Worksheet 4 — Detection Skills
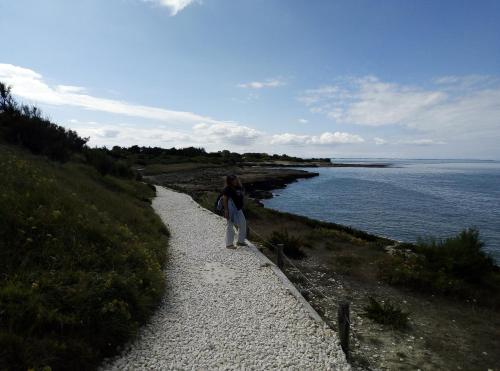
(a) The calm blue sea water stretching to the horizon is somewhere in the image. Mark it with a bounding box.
[264,159,500,262]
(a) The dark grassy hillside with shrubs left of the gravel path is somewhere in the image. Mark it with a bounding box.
[0,84,168,370]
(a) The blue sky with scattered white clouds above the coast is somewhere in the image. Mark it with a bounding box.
[0,0,500,159]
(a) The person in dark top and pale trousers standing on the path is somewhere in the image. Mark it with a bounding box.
[222,175,247,249]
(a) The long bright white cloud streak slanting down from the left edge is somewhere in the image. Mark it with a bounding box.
[0,63,231,125]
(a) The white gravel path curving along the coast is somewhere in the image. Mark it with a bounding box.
[103,187,349,370]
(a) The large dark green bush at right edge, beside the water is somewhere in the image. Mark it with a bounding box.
[379,228,500,306]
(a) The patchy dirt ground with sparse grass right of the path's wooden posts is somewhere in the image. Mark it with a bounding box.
[276,247,500,370]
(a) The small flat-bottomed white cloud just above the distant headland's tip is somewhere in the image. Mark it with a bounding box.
[271,131,365,145]
